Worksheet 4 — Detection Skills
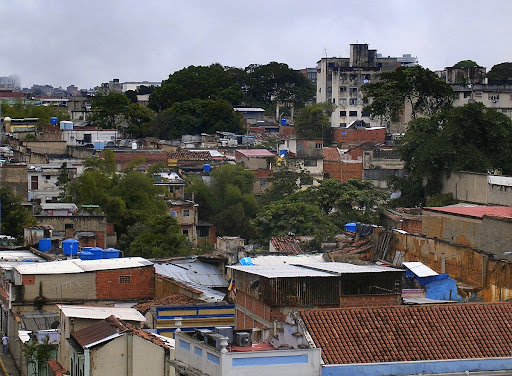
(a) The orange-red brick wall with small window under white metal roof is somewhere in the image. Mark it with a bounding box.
[96,265,155,300]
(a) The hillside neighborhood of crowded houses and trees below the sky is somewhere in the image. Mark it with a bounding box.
[0,43,512,376]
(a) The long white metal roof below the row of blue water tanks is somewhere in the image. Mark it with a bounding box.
[14,257,153,275]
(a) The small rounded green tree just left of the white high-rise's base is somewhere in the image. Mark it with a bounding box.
[294,104,332,143]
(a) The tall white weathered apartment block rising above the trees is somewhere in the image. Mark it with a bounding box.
[316,44,400,128]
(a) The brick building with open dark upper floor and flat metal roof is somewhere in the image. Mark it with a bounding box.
[228,262,404,339]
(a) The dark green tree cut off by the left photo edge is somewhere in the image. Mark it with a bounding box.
[0,186,36,242]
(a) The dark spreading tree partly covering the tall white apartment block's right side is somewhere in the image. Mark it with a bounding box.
[362,65,453,122]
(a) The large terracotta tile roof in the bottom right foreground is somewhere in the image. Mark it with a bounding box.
[301,303,512,364]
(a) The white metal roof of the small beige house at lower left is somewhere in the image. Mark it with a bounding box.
[59,305,146,322]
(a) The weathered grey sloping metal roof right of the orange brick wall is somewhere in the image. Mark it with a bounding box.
[155,260,228,287]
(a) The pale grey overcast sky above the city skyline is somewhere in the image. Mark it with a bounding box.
[4,0,512,88]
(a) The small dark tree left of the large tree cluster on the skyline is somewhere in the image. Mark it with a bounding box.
[91,92,130,129]
